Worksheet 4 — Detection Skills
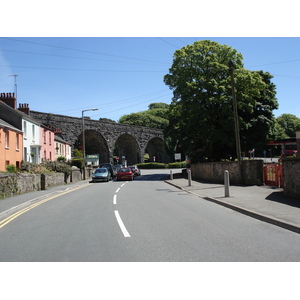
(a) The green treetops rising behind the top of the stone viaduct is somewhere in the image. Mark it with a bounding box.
[119,103,169,129]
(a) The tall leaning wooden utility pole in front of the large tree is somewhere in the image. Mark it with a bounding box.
[229,61,242,179]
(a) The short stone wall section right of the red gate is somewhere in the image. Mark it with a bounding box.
[282,158,300,199]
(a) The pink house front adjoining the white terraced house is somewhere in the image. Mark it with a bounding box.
[40,125,55,161]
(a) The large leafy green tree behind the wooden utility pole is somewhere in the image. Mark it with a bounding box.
[164,40,276,161]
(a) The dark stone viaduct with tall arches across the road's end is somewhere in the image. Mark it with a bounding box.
[30,110,171,165]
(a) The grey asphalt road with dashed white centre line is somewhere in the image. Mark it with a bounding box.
[0,170,300,262]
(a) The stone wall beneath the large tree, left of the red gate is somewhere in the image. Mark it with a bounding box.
[191,160,263,185]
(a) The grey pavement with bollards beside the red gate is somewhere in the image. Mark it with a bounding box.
[165,178,300,233]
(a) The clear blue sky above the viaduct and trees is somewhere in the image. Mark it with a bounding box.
[0,37,300,121]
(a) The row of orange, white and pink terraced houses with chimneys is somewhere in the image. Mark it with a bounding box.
[0,93,71,171]
